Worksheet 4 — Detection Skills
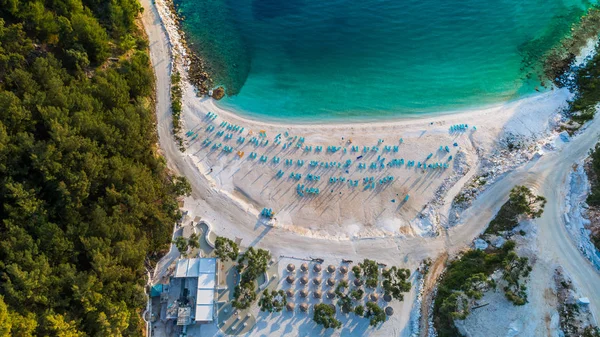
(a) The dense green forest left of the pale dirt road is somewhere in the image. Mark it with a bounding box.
[0,0,189,337]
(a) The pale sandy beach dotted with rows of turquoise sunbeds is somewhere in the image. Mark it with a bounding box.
[179,81,568,239]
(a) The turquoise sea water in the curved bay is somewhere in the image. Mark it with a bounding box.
[175,0,591,120]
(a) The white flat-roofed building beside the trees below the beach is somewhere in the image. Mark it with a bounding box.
[174,258,217,323]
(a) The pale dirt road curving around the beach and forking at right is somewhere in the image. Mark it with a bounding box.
[142,0,600,332]
